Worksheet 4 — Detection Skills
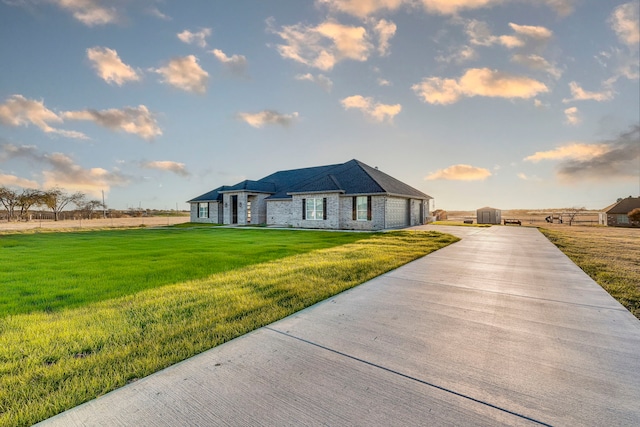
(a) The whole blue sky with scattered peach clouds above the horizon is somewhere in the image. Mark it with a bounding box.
[0,0,640,210]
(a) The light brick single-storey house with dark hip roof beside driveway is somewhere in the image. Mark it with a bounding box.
[188,160,432,230]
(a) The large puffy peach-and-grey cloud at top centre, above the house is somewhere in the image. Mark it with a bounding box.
[267,19,373,71]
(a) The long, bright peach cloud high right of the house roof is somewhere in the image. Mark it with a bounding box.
[411,68,549,105]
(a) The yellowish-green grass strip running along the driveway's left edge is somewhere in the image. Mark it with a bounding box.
[0,230,458,426]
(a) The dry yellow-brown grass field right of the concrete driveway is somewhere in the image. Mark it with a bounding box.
[540,225,640,319]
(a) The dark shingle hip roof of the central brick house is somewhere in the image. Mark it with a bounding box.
[189,159,431,202]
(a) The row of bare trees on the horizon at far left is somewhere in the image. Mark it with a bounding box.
[0,186,106,221]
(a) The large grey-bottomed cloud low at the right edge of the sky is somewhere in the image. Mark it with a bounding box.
[525,125,640,183]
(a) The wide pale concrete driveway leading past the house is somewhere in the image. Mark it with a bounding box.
[37,226,640,426]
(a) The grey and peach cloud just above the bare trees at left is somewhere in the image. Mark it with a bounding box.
[0,144,130,196]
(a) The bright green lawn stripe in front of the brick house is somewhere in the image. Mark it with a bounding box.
[0,228,371,317]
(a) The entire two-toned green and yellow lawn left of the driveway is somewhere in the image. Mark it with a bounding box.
[0,228,457,426]
